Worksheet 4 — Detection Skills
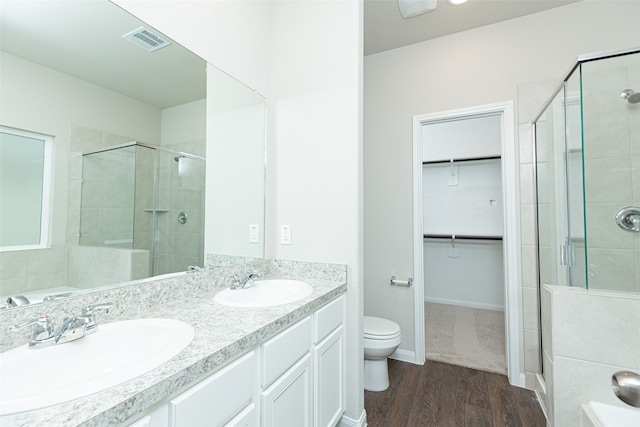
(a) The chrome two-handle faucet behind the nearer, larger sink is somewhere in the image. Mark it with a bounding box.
[11,303,113,349]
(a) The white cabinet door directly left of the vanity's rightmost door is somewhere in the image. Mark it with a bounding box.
[262,353,311,427]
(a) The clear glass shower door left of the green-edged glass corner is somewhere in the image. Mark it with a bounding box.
[535,73,587,288]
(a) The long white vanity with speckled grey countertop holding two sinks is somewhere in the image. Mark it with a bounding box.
[0,263,346,427]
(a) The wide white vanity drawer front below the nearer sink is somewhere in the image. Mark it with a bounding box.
[169,351,257,427]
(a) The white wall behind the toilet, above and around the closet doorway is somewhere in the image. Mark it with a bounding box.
[364,0,640,387]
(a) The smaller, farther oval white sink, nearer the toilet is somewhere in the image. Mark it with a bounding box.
[213,279,313,307]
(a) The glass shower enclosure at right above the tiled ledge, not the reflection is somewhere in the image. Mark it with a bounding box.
[535,50,640,292]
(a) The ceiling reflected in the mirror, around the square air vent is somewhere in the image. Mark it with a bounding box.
[0,0,206,109]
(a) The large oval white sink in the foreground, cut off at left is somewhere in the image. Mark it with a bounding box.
[0,319,194,415]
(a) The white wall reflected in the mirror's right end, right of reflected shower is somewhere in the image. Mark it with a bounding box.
[205,67,266,258]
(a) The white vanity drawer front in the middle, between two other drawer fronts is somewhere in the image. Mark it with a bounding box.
[260,316,311,387]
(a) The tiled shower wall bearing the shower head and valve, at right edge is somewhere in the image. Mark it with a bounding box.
[582,54,640,292]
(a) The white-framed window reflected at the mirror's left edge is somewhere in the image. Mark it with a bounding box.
[0,126,52,251]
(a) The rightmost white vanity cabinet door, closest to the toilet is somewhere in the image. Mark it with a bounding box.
[313,326,345,427]
